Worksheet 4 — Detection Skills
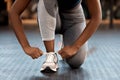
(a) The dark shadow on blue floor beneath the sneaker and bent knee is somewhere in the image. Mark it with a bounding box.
[24,61,89,80]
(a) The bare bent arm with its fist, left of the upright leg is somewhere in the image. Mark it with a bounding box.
[9,0,42,59]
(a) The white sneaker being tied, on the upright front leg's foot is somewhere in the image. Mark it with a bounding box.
[40,52,58,72]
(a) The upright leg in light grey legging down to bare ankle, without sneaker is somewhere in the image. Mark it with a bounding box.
[38,0,57,52]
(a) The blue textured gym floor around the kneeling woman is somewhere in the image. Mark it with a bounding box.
[0,27,120,80]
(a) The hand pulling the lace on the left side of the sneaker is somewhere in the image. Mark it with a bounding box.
[24,47,43,59]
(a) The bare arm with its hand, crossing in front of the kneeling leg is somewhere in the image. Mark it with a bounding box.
[59,0,102,58]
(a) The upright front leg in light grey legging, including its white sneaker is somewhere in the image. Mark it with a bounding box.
[38,0,61,71]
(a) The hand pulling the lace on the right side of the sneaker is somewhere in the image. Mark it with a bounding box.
[58,46,78,58]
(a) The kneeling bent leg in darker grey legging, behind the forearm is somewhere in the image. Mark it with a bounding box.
[60,5,88,68]
